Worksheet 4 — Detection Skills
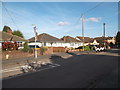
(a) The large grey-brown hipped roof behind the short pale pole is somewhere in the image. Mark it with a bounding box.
[28,33,63,42]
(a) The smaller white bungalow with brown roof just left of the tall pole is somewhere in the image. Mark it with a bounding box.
[61,36,82,48]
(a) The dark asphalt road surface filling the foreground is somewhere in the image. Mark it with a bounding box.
[2,48,119,88]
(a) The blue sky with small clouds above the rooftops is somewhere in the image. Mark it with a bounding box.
[0,2,118,39]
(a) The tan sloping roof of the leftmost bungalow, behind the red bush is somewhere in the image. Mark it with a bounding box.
[0,31,27,41]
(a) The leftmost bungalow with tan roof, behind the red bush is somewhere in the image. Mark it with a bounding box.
[0,31,27,47]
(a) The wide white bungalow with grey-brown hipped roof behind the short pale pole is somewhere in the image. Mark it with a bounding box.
[28,33,64,47]
